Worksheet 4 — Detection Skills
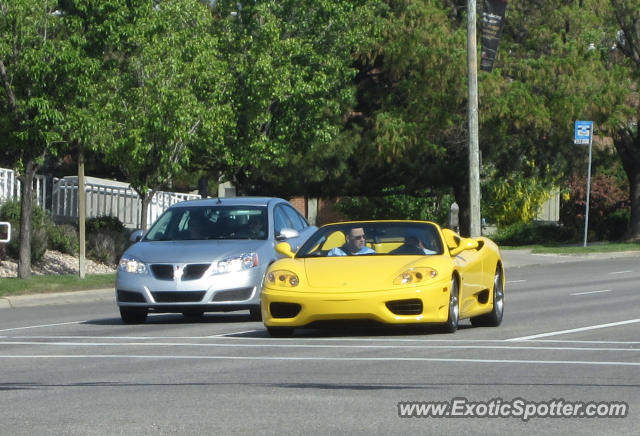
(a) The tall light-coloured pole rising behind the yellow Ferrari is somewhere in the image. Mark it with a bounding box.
[467,0,482,236]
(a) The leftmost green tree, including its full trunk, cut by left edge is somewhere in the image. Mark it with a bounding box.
[0,0,82,278]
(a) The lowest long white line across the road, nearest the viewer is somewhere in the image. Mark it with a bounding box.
[0,354,640,366]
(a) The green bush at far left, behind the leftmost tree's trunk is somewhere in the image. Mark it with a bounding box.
[0,201,52,262]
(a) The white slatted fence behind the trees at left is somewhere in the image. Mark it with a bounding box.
[0,168,200,228]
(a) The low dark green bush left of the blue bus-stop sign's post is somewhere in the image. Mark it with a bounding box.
[491,222,578,246]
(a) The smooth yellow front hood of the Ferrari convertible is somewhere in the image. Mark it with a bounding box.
[304,256,444,292]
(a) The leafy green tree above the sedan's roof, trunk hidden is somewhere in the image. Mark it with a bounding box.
[194,0,365,195]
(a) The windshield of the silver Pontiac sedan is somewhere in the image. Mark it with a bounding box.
[143,206,268,241]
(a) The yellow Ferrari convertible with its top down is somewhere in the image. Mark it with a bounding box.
[261,221,505,336]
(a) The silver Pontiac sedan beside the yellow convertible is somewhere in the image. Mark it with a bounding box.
[116,197,316,323]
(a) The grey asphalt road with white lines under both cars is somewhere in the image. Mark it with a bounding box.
[0,254,640,435]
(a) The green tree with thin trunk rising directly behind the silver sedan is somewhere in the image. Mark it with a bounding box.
[95,0,232,228]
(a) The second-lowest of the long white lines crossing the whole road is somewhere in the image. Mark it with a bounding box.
[0,341,640,352]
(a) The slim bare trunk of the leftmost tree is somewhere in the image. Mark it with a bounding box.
[18,160,36,279]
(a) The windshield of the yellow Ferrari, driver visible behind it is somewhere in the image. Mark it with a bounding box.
[296,221,443,258]
